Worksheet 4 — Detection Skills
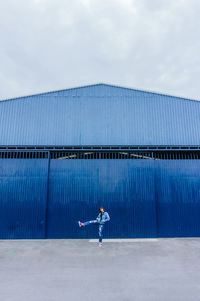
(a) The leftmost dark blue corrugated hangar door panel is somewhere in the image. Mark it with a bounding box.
[0,159,48,239]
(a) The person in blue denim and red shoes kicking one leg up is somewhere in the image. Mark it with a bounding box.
[78,206,110,247]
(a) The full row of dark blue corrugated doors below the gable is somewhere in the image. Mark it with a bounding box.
[0,159,200,239]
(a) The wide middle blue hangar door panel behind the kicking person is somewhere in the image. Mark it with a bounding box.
[47,158,157,238]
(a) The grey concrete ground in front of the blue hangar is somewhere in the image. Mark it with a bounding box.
[0,238,200,301]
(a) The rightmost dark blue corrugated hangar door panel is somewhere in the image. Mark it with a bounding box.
[155,160,200,237]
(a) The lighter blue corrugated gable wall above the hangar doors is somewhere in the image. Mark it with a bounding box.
[0,84,200,145]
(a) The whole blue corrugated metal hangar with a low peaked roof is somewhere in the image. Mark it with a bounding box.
[0,84,200,238]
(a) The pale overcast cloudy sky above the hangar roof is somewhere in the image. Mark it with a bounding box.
[0,0,200,99]
